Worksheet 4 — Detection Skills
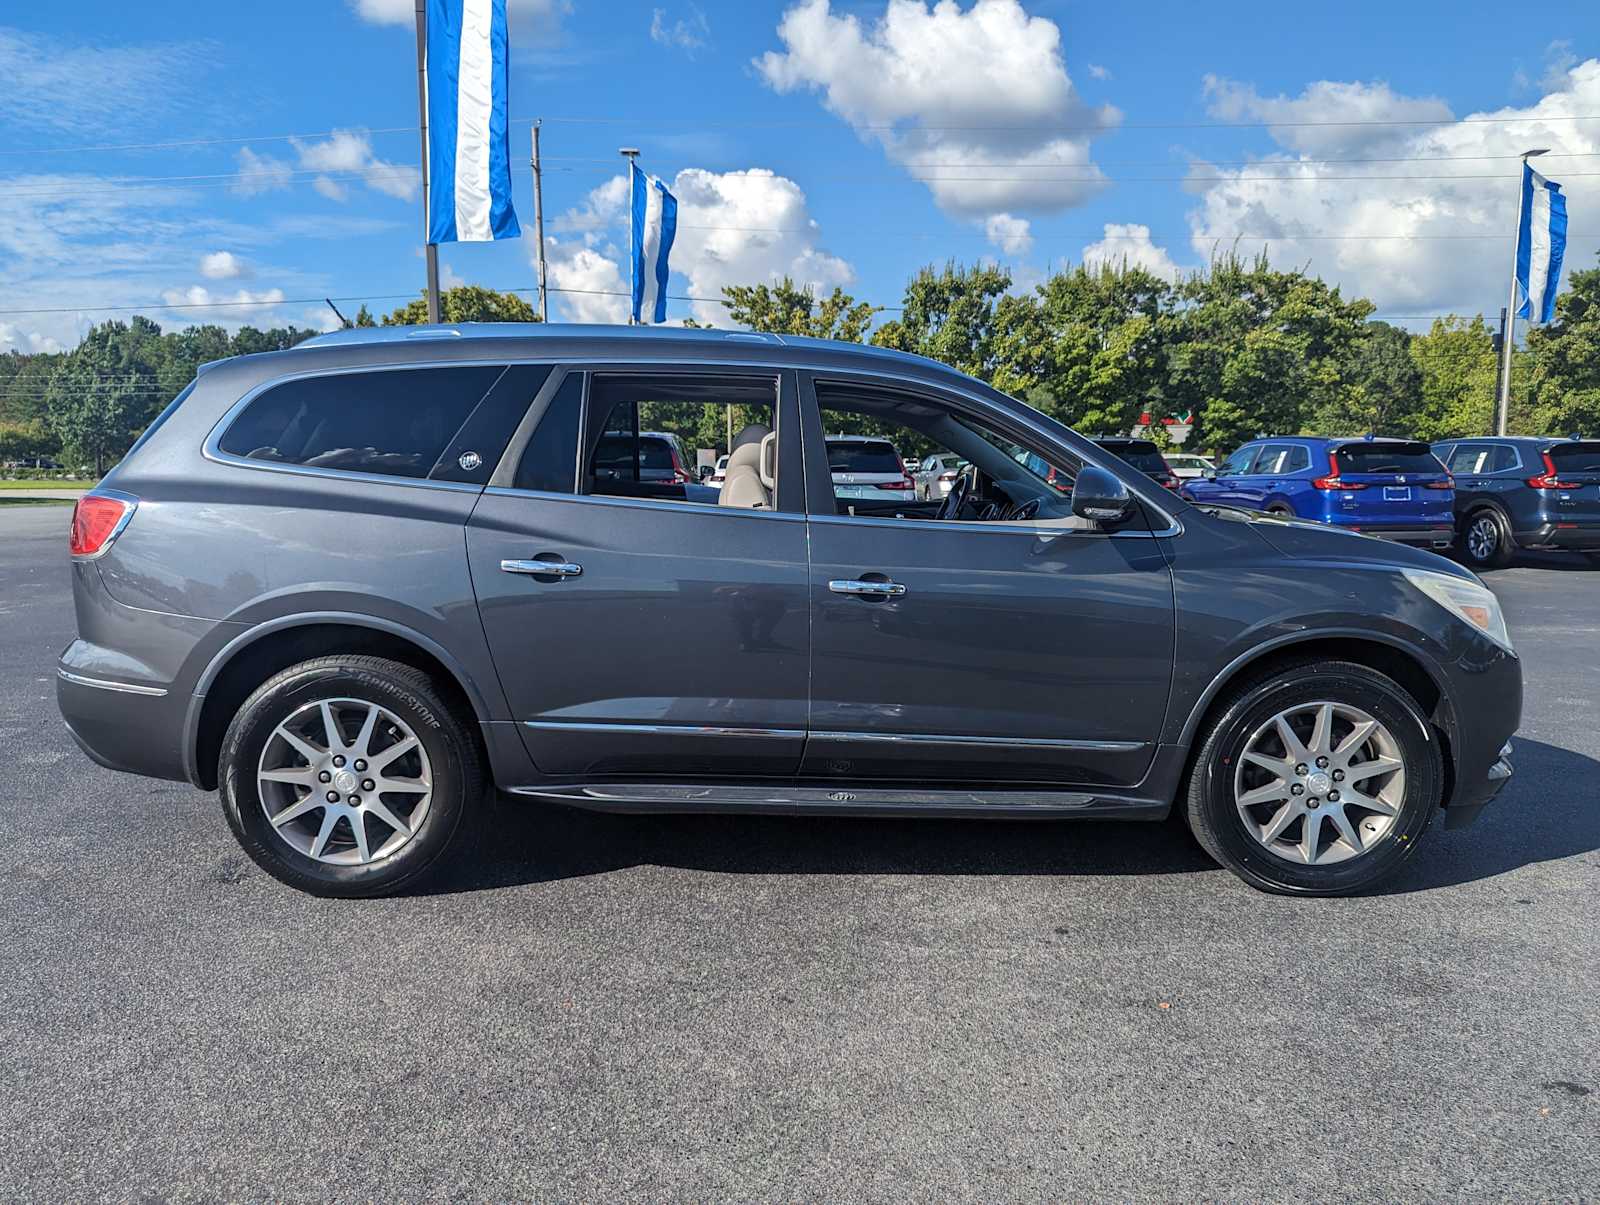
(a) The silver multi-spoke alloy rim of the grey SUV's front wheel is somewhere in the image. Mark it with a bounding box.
[1234,703,1405,866]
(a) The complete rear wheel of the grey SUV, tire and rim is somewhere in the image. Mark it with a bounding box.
[218,656,483,896]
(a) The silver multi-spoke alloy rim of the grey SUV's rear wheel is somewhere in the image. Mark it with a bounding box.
[256,699,434,866]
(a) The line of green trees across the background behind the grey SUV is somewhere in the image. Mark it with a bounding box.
[0,253,1600,474]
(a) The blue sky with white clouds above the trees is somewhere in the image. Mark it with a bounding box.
[0,0,1600,349]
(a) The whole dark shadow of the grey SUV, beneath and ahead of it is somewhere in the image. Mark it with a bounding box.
[422,739,1600,895]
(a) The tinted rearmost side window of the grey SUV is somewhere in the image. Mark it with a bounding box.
[218,366,504,477]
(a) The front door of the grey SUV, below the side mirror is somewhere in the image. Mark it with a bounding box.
[802,381,1173,787]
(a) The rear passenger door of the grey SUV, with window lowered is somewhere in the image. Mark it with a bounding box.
[467,368,810,783]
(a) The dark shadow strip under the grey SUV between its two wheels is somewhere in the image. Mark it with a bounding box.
[422,800,1219,893]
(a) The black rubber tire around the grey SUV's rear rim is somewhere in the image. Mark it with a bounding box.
[218,666,467,896]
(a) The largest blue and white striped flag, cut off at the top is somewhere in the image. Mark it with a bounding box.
[427,0,522,243]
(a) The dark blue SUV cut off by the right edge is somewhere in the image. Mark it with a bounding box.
[1434,435,1600,570]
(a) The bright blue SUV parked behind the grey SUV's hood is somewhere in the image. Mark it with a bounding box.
[1179,435,1456,549]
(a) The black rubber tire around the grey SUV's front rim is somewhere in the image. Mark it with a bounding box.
[1195,666,1443,895]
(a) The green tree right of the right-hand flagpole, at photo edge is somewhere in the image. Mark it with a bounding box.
[1512,254,1600,435]
